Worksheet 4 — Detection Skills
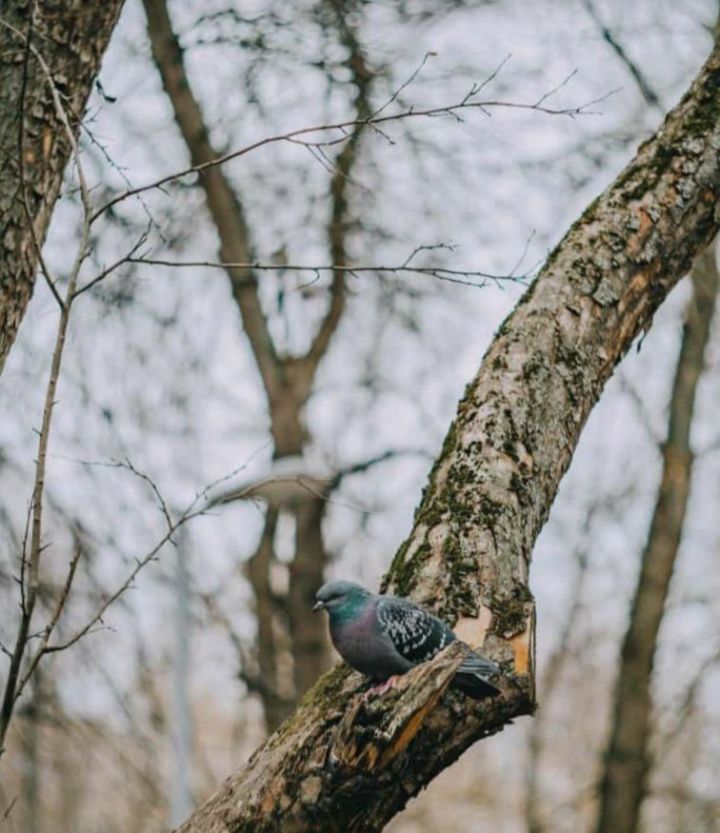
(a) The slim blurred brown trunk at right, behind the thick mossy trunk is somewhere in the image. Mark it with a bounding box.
[596,247,718,833]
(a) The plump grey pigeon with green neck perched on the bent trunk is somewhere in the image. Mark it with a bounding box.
[313,581,501,700]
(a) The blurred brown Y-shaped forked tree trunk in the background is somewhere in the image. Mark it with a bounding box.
[144,0,373,731]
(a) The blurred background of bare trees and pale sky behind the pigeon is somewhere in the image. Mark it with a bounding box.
[0,0,720,833]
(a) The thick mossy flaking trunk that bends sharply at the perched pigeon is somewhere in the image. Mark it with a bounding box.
[173,42,720,833]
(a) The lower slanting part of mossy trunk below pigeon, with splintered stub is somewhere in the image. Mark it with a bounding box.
[178,641,532,833]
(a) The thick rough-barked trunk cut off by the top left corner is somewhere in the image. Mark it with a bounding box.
[0,0,123,372]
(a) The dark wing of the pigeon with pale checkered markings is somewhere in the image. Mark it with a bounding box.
[377,596,455,665]
